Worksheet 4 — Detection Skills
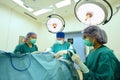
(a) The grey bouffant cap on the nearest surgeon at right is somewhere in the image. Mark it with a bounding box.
[82,26,107,44]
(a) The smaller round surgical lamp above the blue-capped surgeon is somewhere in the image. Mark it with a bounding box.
[46,14,65,33]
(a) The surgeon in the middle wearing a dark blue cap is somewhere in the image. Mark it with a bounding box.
[49,32,75,60]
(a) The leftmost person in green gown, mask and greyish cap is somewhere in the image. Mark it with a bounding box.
[14,32,38,54]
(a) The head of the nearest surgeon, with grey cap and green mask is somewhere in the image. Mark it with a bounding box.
[82,26,107,46]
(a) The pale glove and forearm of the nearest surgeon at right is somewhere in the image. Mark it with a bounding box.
[72,54,89,73]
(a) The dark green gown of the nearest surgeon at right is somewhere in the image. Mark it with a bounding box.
[83,45,119,80]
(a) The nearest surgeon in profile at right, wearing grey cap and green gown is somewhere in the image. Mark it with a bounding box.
[72,26,120,80]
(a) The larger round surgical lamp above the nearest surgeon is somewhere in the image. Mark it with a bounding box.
[74,0,113,25]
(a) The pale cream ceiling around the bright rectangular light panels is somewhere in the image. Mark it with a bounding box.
[0,0,120,23]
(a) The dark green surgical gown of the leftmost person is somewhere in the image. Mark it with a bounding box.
[14,43,38,54]
